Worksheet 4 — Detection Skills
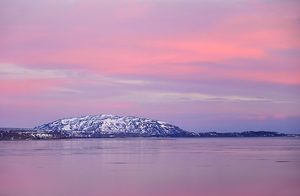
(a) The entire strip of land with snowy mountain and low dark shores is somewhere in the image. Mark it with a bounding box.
[0,114,300,140]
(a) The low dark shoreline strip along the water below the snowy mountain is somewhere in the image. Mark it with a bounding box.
[0,128,300,140]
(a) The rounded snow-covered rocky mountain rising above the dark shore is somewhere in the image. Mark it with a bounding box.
[34,115,191,137]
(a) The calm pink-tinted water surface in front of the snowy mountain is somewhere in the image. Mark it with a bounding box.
[0,138,300,196]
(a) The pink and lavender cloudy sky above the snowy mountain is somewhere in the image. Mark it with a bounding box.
[0,0,300,132]
